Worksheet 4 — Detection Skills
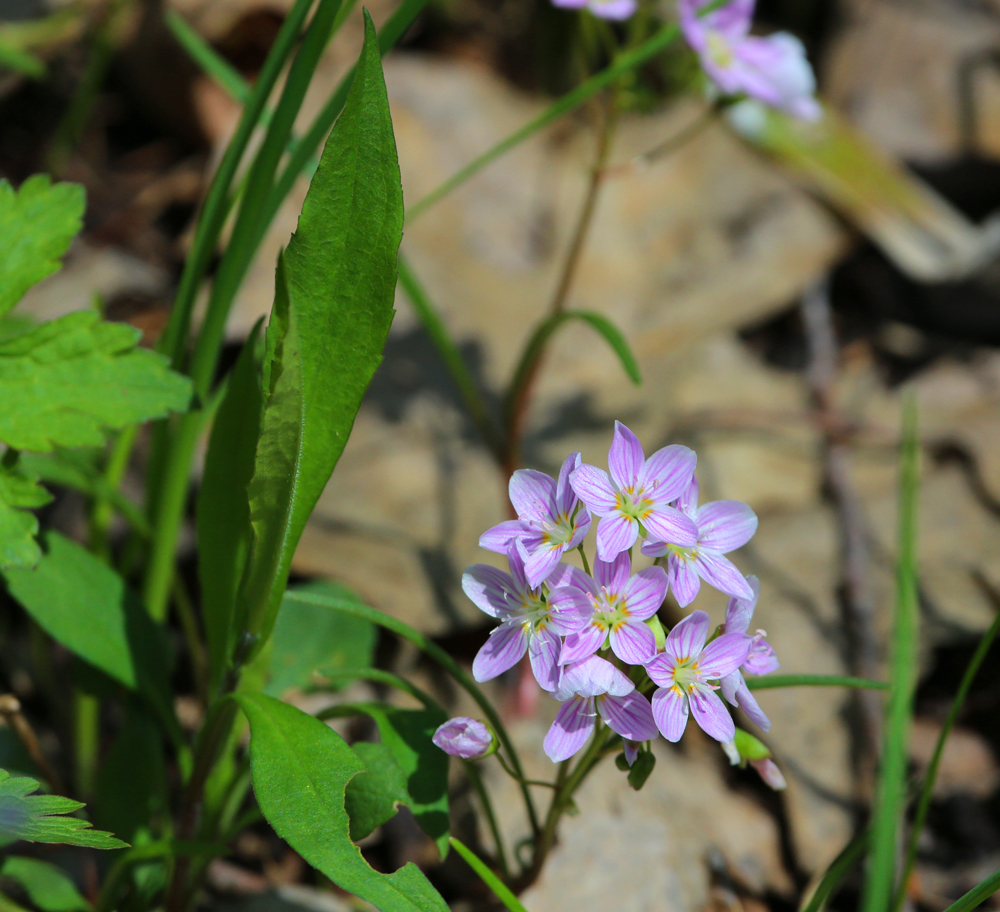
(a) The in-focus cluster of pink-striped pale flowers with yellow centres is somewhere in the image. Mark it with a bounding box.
[456,422,778,763]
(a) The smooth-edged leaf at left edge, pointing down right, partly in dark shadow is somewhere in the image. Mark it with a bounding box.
[4,532,176,726]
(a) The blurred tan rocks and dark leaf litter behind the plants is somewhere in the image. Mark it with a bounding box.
[0,0,1000,912]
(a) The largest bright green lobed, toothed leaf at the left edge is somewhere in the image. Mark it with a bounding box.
[0,311,191,452]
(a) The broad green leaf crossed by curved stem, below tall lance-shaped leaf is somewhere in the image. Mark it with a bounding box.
[264,581,376,697]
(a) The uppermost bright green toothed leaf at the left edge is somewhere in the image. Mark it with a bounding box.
[0,174,85,314]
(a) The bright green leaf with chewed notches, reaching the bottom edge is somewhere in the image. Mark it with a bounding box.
[235,693,448,912]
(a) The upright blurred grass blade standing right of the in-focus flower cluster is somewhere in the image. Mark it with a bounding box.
[861,398,920,912]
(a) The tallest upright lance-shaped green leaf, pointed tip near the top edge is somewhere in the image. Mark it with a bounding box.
[239,15,403,649]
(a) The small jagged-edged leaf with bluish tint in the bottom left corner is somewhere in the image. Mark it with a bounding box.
[0,770,128,849]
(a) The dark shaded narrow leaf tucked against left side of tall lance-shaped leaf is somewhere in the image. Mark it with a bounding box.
[196,323,262,687]
